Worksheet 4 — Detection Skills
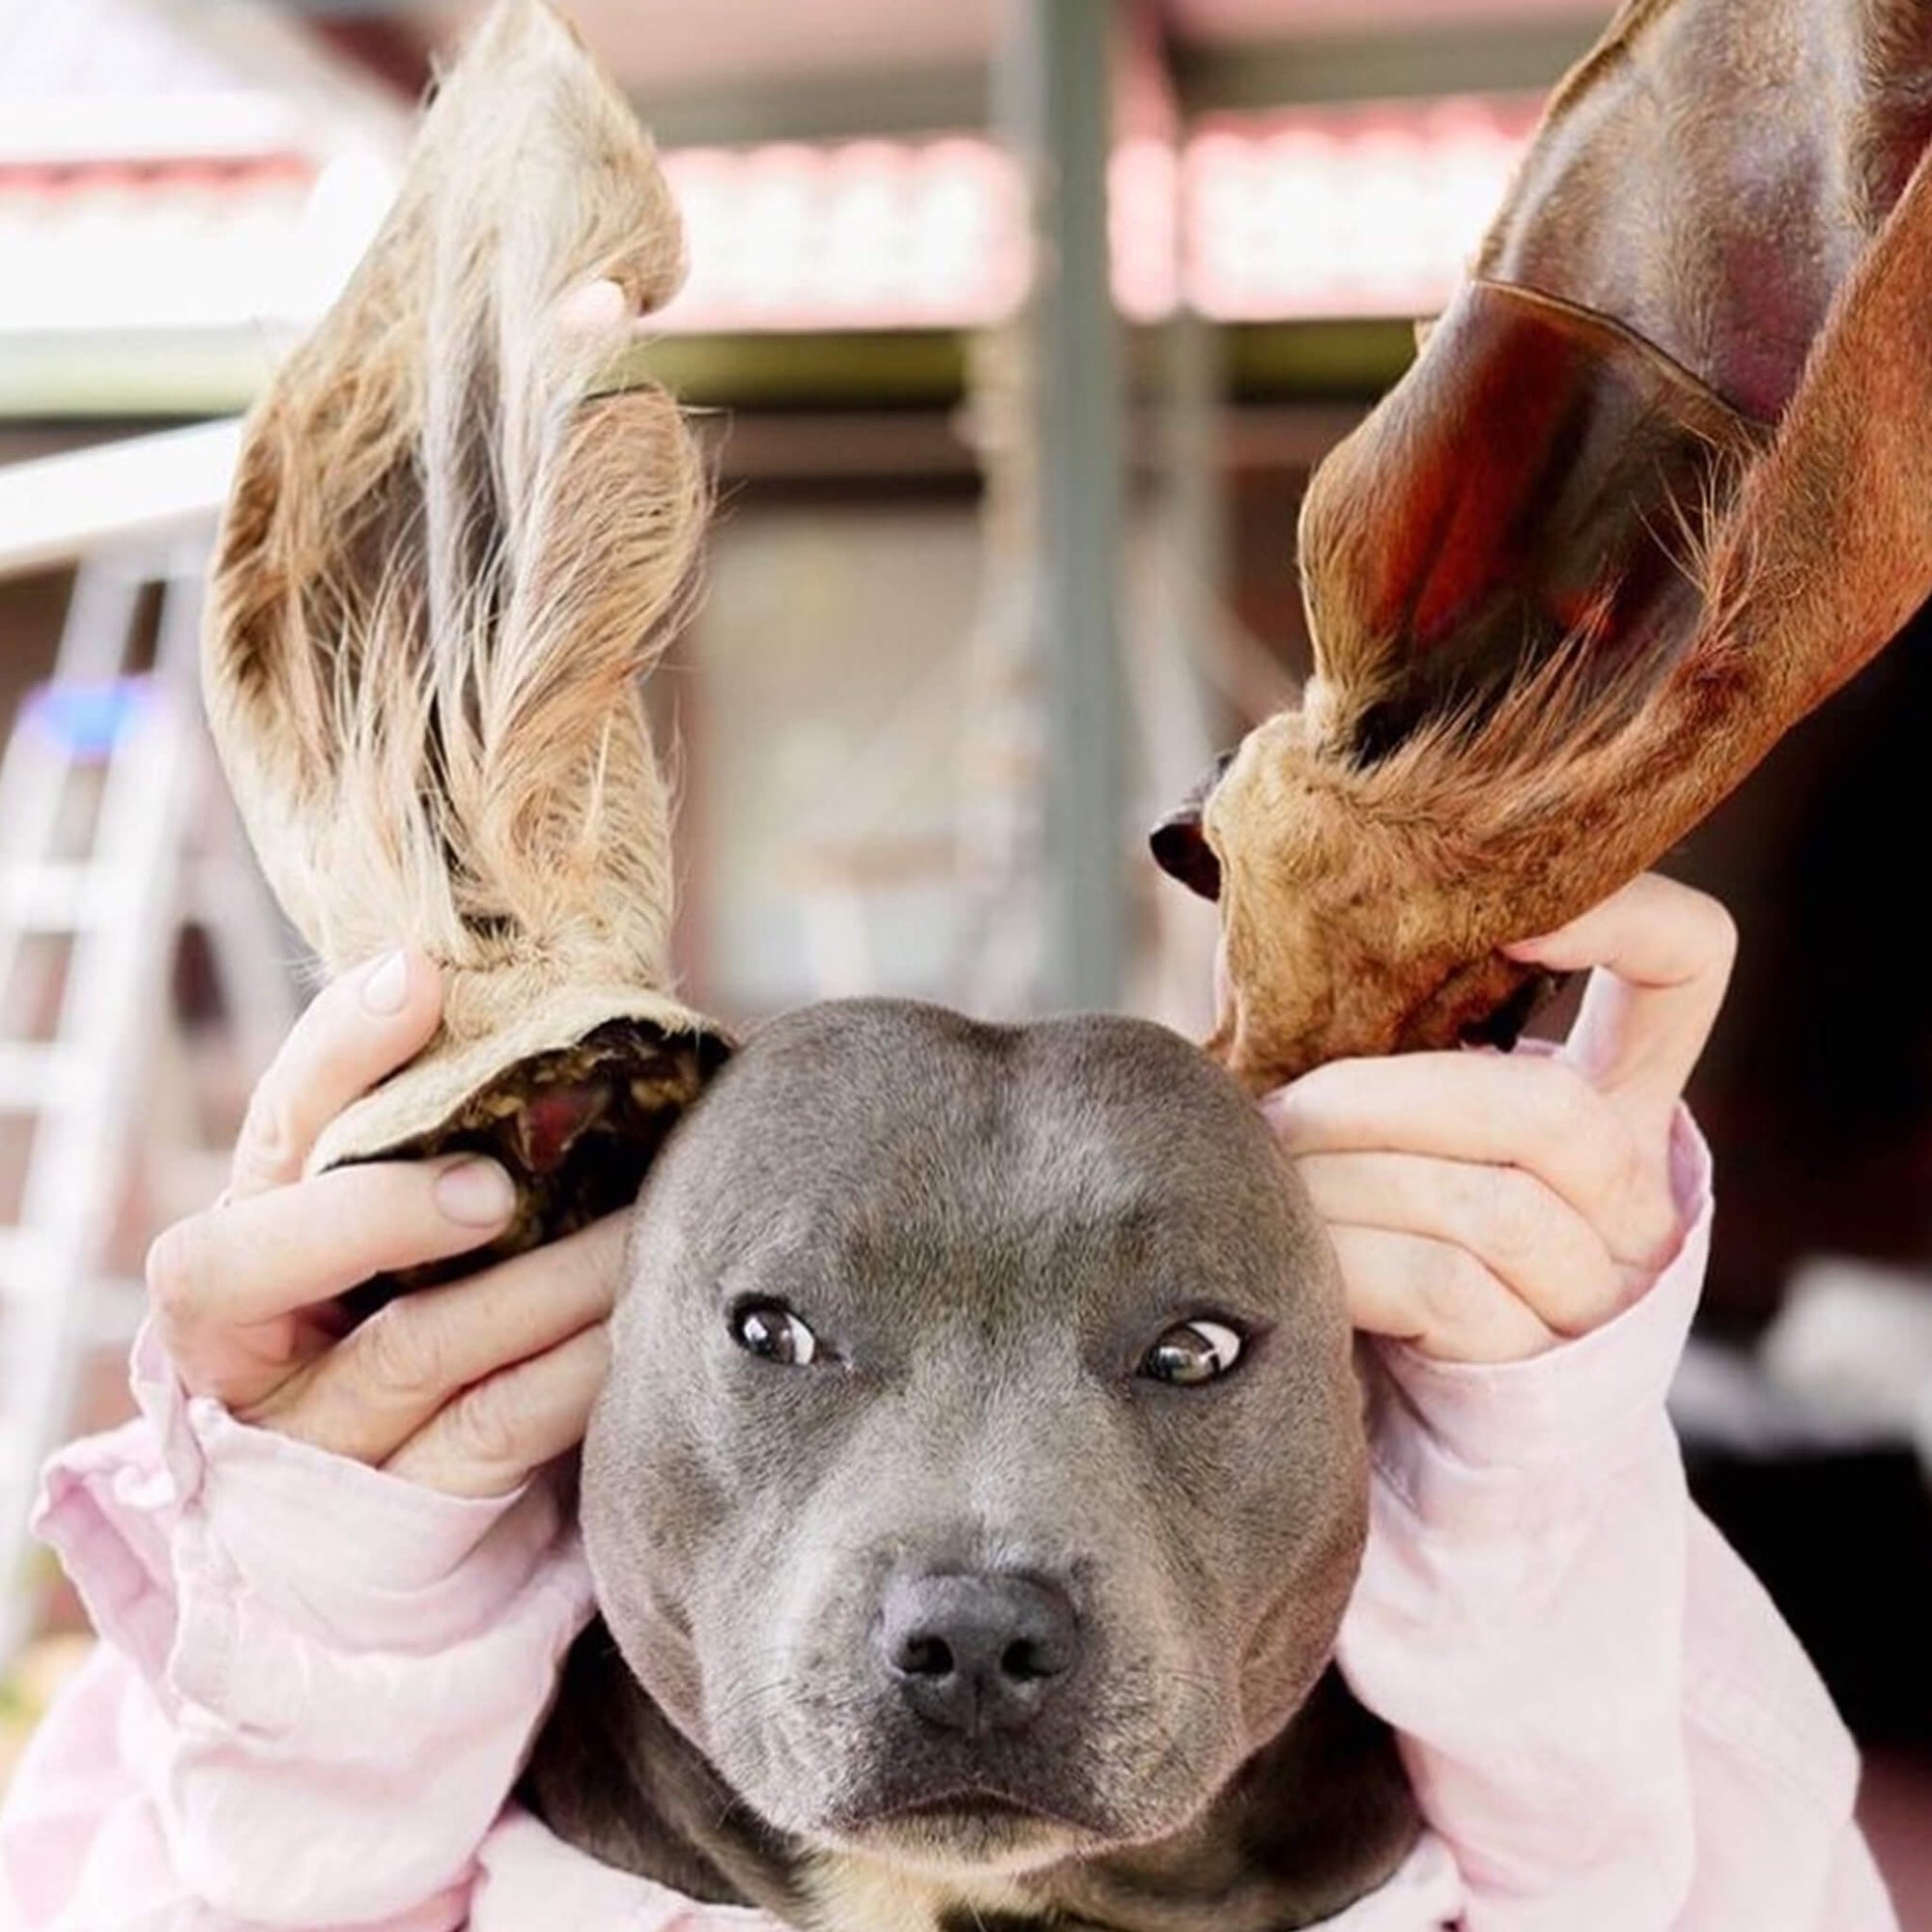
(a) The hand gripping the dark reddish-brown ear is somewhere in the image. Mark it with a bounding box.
[1262,873,1737,1362]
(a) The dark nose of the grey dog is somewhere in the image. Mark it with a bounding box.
[877,1575,1080,1737]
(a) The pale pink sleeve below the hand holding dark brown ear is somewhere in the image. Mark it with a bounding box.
[1341,1117,1895,1932]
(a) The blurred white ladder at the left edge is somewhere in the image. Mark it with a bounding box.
[0,539,292,1665]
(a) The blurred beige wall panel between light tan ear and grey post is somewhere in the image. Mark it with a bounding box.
[688,497,981,1014]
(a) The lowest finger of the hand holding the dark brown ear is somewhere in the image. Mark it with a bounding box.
[1329,1227,1555,1362]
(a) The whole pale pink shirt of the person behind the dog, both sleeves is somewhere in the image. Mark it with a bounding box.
[0,1124,1897,1932]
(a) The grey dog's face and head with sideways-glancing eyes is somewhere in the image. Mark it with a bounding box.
[583,1001,1366,1872]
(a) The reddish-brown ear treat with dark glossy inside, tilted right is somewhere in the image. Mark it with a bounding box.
[1163,0,1932,1088]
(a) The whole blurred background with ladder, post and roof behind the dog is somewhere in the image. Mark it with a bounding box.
[0,0,1932,1926]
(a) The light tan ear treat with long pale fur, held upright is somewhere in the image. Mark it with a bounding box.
[203,0,726,1291]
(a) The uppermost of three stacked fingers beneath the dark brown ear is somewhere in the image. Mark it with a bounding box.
[1262,1053,1673,1258]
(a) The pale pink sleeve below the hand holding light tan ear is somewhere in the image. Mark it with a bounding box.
[0,1341,589,1932]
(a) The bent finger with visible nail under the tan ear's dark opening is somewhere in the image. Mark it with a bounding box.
[147,1155,516,1408]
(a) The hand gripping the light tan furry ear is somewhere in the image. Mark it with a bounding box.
[147,952,624,1495]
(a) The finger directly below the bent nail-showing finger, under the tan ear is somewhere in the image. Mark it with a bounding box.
[249,1215,628,1468]
